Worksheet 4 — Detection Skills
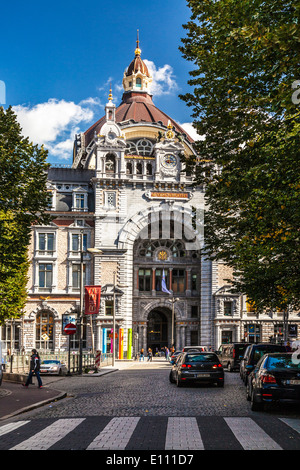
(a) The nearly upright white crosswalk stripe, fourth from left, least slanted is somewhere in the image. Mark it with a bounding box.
[165,417,204,450]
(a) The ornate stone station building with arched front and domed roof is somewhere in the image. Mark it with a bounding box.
[1,41,300,358]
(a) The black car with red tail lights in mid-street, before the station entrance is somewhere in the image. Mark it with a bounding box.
[170,352,224,387]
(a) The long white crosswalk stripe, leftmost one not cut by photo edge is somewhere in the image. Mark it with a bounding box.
[10,418,85,450]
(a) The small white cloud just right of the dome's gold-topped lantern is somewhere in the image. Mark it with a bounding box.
[144,59,178,96]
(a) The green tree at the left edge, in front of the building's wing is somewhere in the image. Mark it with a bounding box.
[0,107,50,323]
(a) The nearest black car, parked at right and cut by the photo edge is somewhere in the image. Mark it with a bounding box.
[247,352,300,411]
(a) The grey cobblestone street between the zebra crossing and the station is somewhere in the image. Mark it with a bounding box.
[22,358,300,418]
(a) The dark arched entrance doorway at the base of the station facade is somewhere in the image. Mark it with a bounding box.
[147,309,169,354]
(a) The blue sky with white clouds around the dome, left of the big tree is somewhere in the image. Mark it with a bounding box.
[0,0,198,165]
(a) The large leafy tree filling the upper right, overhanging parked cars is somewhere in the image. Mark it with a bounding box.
[180,0,300,309]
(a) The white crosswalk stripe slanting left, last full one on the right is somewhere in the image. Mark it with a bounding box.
[224,418,282,450]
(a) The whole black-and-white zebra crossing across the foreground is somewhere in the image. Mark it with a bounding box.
[0,415,300,452]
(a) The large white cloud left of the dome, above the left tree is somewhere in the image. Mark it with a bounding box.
[13,98,101,159]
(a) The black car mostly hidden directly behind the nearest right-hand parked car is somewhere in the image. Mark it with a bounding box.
[240,343,286,385]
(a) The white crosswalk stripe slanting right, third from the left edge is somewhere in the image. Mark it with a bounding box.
[87,417,140,450]
